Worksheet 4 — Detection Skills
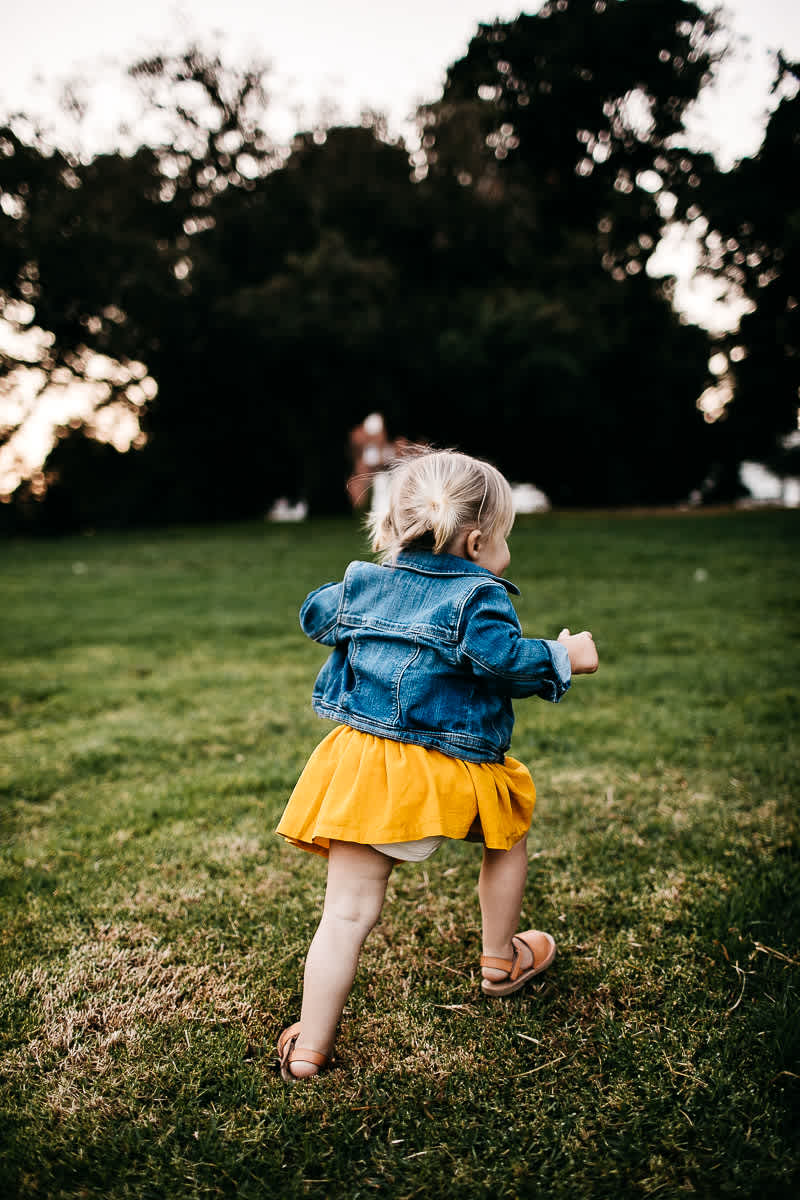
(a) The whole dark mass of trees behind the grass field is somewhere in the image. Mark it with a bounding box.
[0,0,798,528]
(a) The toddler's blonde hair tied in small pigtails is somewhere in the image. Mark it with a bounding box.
[367,448,513,563]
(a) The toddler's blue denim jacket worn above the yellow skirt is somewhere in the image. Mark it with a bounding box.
[300,552,571,762]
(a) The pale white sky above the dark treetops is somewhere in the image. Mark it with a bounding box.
[0,0,800,166]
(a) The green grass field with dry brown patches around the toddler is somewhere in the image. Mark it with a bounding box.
[0,512,800,1200]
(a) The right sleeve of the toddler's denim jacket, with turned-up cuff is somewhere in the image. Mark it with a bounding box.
[461,584,572,704]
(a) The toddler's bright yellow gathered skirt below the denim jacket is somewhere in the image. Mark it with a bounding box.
[277,725,536,857]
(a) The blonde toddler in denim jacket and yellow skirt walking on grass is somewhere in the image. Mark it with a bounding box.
[277,450,597,1080]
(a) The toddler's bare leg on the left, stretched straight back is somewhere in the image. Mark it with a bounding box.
[290,841,395,1079]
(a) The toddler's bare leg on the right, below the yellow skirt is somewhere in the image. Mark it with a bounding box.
[477,838,548,979]
